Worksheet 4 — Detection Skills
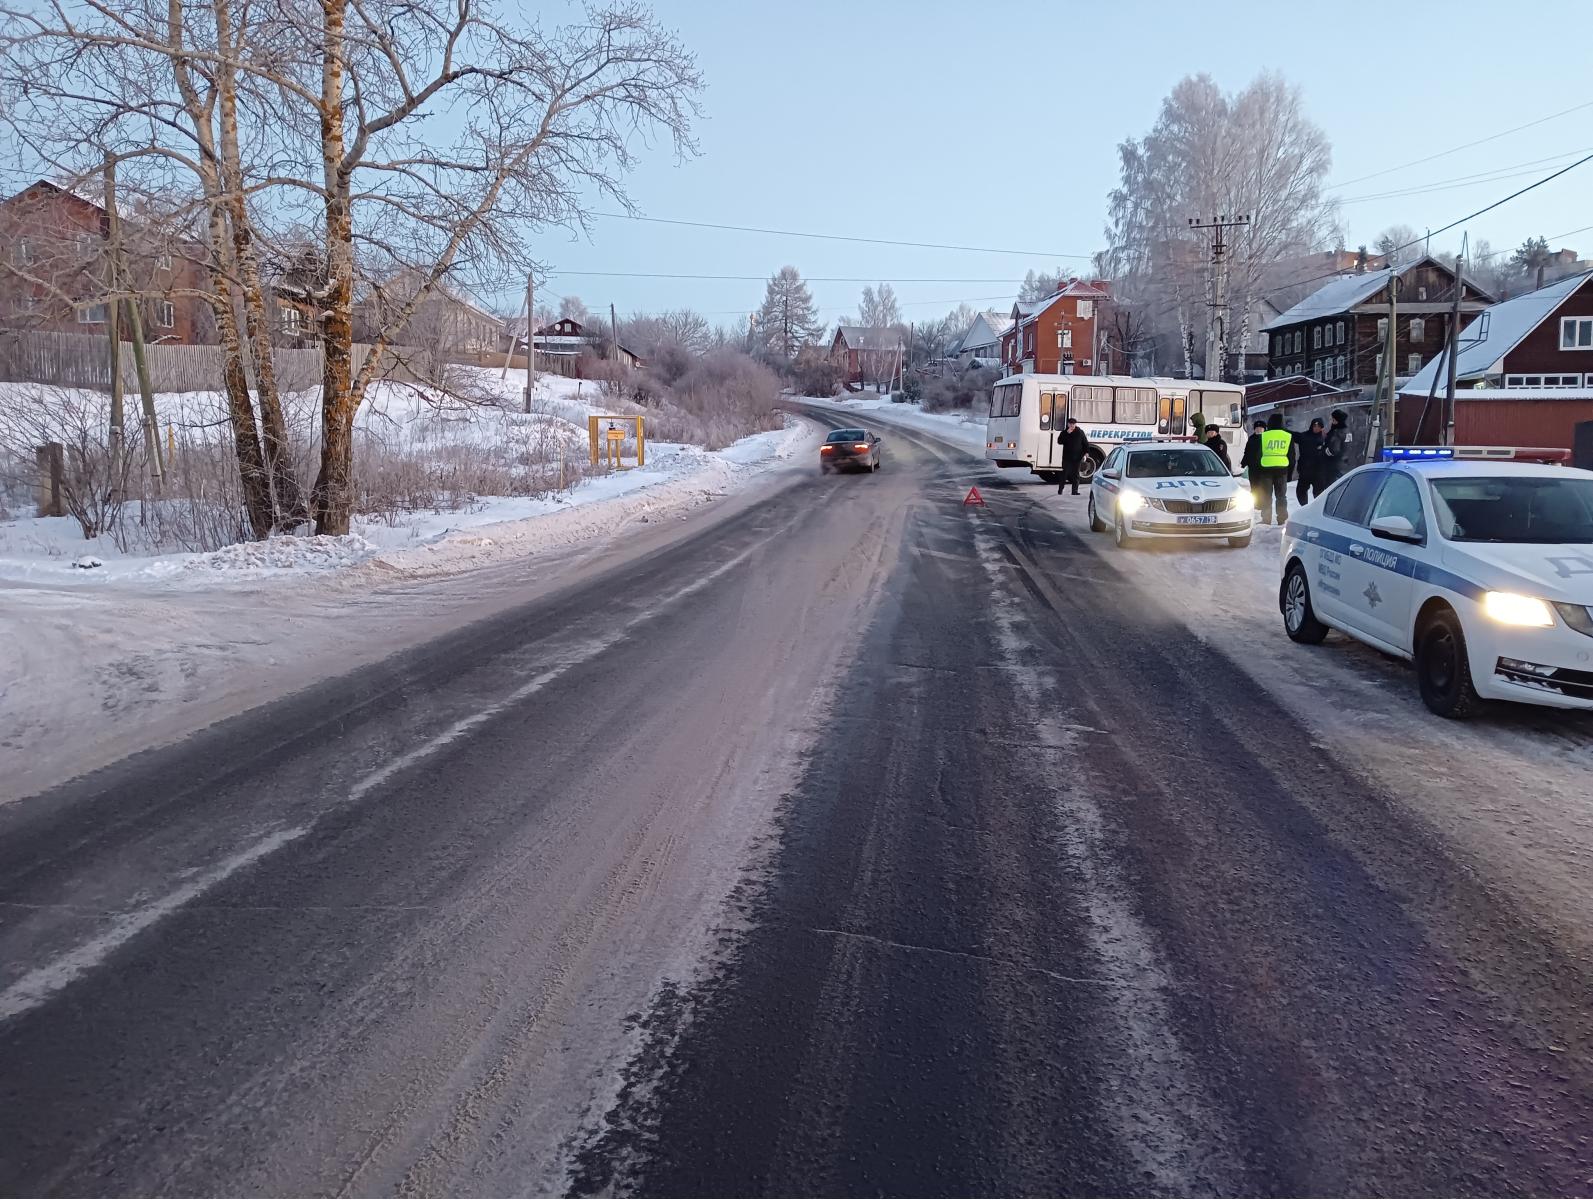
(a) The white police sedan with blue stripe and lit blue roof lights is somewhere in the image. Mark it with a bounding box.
[1278,448,1593,717]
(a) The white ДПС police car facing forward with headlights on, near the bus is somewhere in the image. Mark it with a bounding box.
[1088,441,1255,547]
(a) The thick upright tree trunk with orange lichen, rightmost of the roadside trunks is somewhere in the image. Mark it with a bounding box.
[311,0,358,535]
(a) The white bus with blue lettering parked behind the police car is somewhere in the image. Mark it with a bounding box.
[984,375,1244,483]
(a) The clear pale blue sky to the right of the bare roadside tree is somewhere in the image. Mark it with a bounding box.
[538,0,1593,322]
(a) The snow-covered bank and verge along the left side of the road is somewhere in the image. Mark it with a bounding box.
[0,373,819,800]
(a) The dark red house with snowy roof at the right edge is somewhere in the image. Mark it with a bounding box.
[1395,273,1593,449]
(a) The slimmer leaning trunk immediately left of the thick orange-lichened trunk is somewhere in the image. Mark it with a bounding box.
[215,0,309,529]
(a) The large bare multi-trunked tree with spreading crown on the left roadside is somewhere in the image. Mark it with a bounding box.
[0,0,701,534]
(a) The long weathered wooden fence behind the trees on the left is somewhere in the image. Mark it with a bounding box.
[0,330,422,394]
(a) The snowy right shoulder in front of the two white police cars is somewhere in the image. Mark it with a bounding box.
[1040,489,1593,951]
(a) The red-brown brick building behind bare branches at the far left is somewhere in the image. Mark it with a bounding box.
[0,180,215,344]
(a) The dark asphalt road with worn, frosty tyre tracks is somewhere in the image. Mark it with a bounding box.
[0,407,1593,1195]
